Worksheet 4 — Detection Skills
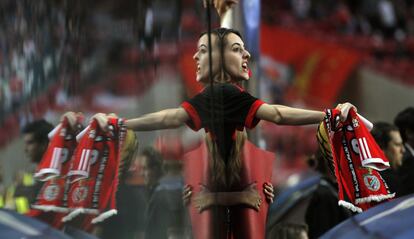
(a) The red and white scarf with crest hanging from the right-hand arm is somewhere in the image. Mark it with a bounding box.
[324,109,394,212]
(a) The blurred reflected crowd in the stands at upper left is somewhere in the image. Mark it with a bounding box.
[0,0,160,145]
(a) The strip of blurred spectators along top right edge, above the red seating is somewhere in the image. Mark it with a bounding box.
[263,0,414,41]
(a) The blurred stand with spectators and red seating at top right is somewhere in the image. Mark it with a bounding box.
[262,0,414,85]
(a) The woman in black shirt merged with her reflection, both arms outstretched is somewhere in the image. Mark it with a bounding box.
[64,24,352,239]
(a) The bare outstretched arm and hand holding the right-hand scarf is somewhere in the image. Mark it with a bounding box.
[256,103,355,125]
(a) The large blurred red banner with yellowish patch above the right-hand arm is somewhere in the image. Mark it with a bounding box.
[260,25,362,108]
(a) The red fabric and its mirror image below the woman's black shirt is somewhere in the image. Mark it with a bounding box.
[184,141,274,239]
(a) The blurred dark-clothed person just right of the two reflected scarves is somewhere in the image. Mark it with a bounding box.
[100,147,162,239]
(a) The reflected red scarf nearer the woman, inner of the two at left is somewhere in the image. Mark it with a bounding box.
[63,119,126,223]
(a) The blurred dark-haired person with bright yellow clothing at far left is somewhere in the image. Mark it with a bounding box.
[4,119,53,214]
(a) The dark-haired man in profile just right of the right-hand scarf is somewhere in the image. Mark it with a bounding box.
[371,122,405,197]
